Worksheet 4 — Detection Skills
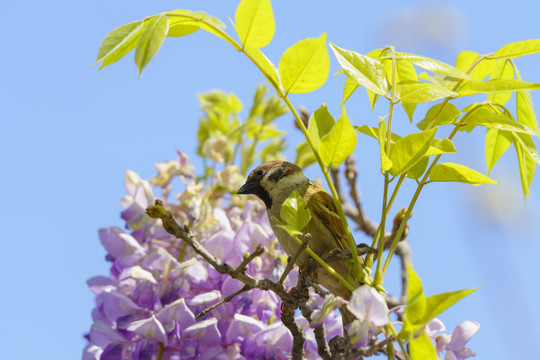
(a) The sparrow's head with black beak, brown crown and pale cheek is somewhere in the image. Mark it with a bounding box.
[238,161,307,209]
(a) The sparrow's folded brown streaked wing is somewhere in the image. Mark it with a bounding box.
[308,183,349,250]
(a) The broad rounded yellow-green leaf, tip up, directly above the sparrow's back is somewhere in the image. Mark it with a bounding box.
[279,33,330,94]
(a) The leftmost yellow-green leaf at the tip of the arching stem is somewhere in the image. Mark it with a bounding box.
[94,20,144,69]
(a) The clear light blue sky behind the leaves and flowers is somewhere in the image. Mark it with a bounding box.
[0,0,540,360]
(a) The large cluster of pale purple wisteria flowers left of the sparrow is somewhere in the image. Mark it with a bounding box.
[83,152,342,360]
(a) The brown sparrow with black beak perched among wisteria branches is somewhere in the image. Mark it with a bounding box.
[237,161,354,326]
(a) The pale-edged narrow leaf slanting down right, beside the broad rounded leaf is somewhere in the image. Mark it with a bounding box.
[330,43,388,95]
